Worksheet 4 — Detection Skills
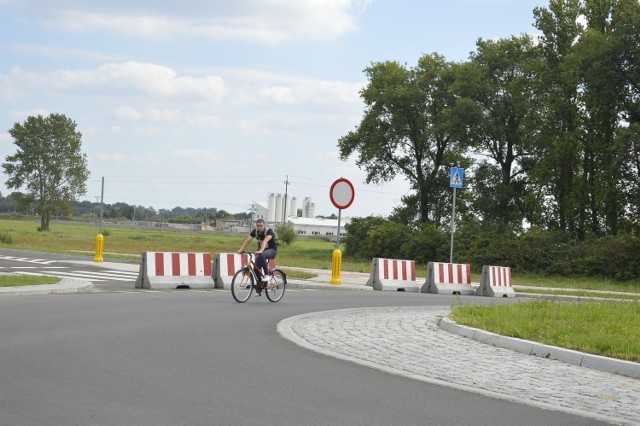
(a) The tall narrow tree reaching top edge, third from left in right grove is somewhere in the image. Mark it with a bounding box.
[532,0,584,237]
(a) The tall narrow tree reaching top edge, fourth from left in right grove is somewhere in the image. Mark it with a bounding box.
[572,0,627,234]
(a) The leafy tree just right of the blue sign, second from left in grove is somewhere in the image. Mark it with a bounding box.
[457,35,541,226]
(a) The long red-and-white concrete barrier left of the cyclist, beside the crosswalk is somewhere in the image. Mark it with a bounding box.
[136,252,213,290]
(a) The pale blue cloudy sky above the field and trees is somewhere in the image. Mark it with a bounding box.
[0,0,548,217]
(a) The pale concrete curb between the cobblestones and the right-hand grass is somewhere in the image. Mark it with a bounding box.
[438,318,640,379]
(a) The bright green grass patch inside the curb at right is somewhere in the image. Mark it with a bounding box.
[451,301,640,362]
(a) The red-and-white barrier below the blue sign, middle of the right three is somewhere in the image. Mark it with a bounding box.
[422,262,474,294]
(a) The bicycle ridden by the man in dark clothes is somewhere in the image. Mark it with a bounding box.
[231,253,287,303]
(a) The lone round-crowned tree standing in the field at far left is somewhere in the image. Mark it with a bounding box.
[2,114,89,231]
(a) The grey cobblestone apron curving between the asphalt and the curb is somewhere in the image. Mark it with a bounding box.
[278,307,640,425]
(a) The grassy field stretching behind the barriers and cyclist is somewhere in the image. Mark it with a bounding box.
[0,219,640,292]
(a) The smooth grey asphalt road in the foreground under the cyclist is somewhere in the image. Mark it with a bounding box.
[0,290,600,425]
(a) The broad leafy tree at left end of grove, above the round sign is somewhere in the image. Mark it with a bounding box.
[338,54,464,224]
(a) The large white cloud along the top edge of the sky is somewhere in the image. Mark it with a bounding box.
[6,0,372,44]
